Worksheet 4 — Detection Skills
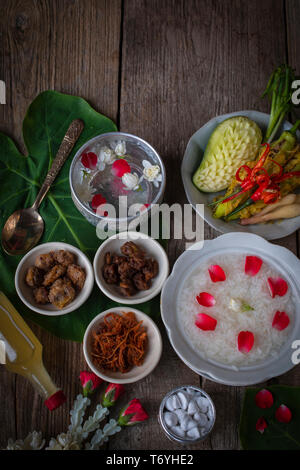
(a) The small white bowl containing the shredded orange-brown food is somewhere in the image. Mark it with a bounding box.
[83,307,162,384]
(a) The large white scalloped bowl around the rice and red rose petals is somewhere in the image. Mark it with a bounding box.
[161,232,300,385]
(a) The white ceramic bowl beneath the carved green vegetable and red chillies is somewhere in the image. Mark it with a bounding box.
[181,111,300,240]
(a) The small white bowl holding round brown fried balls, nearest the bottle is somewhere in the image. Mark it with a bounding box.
[15,242,94,316]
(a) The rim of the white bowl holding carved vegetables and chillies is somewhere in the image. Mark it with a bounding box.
[181,109,300,240]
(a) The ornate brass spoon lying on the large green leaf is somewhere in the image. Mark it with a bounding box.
[2,119,84,255]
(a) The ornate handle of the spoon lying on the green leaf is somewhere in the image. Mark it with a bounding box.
[32,119,84,209]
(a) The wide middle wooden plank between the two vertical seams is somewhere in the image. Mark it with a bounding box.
[113,0,285,449]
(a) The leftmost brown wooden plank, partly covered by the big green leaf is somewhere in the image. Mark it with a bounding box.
[0,0,121,447]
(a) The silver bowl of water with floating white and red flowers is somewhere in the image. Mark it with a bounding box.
[69,132,166,229]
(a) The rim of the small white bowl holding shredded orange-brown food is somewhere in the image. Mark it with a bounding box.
[82,305,163,384]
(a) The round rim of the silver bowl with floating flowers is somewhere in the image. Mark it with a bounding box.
[69,131,166,223]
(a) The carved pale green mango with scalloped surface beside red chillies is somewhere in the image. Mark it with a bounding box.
[193,116,262,192]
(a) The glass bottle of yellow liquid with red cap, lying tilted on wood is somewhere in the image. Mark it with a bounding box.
[0,292,66,410]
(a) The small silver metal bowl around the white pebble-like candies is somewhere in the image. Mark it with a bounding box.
[158,385,216,445]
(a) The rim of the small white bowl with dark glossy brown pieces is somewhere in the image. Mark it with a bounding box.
[93,231,170,305]
